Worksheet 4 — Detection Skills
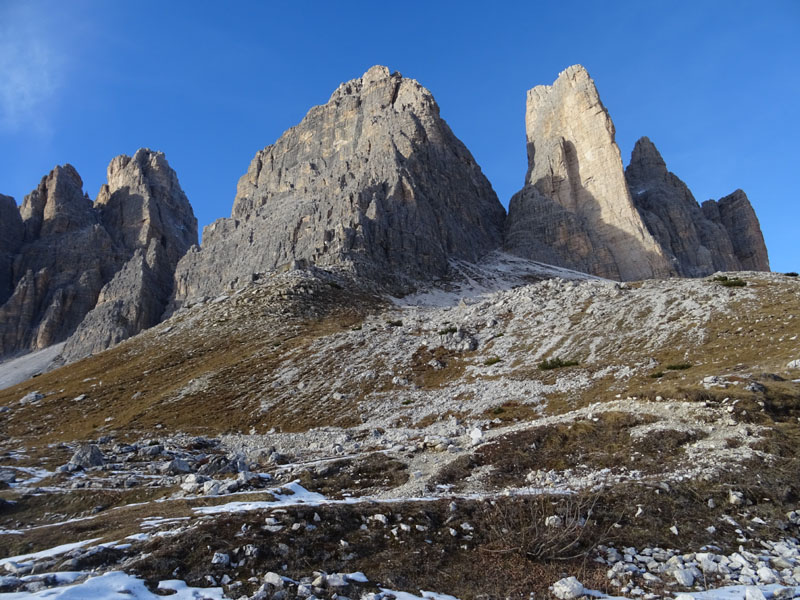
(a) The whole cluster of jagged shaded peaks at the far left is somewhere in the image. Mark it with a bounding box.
[0,150,197,359]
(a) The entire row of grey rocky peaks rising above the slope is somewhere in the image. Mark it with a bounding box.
[0,65,769,370]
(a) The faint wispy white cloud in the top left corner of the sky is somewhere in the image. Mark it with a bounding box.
[0,0,67,133]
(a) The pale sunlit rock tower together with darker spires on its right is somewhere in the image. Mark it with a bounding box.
[505,65,769,280]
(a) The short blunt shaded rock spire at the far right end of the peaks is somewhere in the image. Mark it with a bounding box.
[702,190,769,271]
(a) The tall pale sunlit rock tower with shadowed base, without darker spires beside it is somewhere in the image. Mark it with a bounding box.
[505,65,674,280]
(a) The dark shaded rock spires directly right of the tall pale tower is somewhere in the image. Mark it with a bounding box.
[625,137,769,277]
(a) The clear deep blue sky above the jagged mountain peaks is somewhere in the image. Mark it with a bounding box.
[0,0,800,271]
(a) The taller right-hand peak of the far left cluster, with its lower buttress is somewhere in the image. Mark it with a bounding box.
[63,149,197,361]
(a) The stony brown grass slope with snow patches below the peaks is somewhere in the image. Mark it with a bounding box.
[0,264,800,599]
